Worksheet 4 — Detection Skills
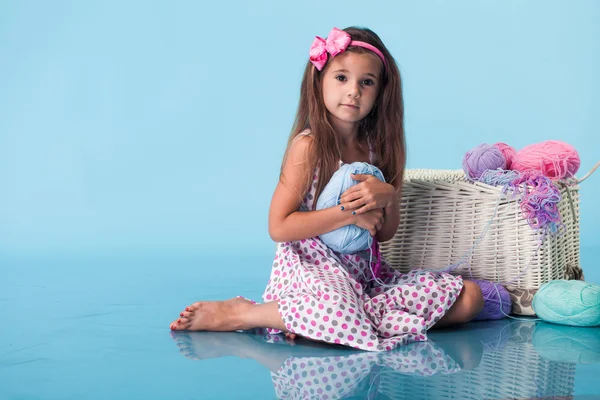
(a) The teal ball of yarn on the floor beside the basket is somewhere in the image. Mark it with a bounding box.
[532,279,600,326]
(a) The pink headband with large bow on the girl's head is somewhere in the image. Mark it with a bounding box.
[309,28,387,71]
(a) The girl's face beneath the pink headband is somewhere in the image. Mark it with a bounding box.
[322,52,383,132]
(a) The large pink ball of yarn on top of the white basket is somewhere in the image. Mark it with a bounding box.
[511,140,581,179]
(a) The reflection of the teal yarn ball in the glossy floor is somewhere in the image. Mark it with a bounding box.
[531,322,600,364]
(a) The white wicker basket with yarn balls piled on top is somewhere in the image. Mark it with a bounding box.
[381,170,580,315]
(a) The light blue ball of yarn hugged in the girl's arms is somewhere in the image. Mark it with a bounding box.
[316,162,385,254]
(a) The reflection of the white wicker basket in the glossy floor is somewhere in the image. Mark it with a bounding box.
[379,322,575,400]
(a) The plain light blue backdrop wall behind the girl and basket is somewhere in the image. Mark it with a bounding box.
[0,0,600,277]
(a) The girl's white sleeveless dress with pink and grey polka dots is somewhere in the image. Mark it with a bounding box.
[263,152,463,351]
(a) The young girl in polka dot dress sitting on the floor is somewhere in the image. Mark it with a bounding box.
[171,27,483,351]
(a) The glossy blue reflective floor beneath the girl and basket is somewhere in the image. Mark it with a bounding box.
[0,248,600,399]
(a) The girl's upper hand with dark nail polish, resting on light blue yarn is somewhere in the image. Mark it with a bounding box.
[340,174,396,215]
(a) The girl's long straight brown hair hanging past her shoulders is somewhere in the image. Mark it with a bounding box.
[280,27,406,209]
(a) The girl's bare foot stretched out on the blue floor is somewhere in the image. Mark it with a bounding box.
[171,297,253,332]
